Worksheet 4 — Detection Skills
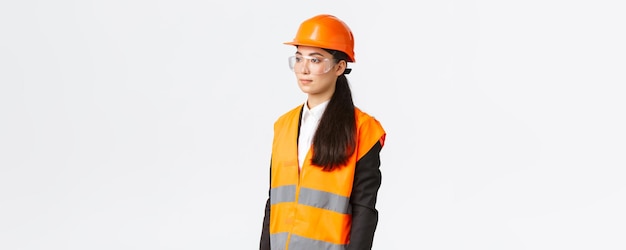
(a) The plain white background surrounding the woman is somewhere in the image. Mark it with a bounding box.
[0,0,626,250]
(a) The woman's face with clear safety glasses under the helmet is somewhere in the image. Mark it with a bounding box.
[291,46,346,100]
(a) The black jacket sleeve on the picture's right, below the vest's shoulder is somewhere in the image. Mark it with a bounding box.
[346,141,382,250]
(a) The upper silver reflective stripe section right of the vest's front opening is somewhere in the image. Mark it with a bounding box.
[298,188,352,214]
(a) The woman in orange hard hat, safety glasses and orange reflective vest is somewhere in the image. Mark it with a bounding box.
[260,14,386,250]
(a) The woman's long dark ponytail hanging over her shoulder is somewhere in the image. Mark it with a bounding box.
[311,50,356,171]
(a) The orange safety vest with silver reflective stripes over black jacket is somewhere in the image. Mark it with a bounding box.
[269,106,385,250]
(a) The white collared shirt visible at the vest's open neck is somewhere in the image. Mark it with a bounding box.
[298,100,330,169]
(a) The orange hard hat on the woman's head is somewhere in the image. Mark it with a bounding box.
[284,14,355,62]
